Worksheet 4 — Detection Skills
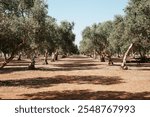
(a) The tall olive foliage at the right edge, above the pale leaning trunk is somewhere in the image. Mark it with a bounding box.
[125,0,150,56]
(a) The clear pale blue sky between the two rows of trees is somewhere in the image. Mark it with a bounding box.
[47,0,128,46]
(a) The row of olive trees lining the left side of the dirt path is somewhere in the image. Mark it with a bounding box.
[0,0,78,69]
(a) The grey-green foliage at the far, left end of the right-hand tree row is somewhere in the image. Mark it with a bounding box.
[80,21,112,54]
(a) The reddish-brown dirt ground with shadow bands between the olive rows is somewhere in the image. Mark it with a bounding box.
[0,56,150,100]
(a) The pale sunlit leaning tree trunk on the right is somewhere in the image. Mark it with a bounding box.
[121,43,133,70]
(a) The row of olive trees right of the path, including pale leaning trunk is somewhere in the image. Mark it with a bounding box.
[80,0,150,69]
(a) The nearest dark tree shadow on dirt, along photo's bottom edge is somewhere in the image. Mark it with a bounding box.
[21,90,150,100]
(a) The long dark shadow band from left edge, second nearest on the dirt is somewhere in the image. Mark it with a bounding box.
[0,75,124,88]
